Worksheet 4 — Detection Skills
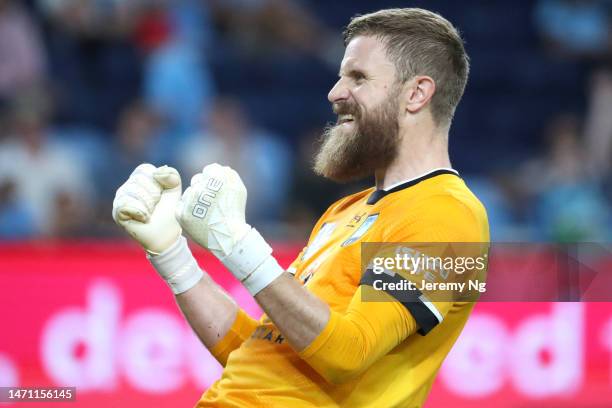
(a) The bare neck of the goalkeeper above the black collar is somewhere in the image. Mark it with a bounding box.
[375,124,451,189]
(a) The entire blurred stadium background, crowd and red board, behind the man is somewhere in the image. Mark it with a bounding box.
[0,0,612,407]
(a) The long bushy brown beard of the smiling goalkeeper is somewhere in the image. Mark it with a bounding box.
[314,92,399,182]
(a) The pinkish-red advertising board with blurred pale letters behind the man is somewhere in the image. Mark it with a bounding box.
[0,242,612,408]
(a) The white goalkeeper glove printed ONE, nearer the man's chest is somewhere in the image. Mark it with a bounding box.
[176,163,284,296]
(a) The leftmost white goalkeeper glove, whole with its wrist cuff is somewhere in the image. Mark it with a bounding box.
[113,163,203,294]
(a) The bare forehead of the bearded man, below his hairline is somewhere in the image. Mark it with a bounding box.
[340,36,395,75]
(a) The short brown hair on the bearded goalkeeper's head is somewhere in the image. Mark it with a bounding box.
[344,8,470,126]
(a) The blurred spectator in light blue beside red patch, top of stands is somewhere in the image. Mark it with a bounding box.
[135,1,214,135]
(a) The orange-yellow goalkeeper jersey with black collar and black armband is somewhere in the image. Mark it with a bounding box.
[198,169,489,408]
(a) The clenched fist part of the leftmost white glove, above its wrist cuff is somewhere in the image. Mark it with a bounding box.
[113,163,181,255]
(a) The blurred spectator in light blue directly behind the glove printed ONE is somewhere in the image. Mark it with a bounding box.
[177,98,291,230]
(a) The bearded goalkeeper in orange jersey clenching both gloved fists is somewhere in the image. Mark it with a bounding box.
[113,8,489,407]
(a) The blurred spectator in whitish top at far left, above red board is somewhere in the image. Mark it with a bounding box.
[0,93,92,236]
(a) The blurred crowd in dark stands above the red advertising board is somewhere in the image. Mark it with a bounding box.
[0,0,612,241]
